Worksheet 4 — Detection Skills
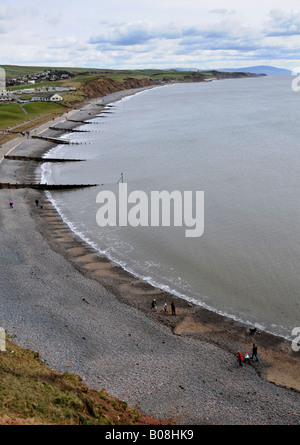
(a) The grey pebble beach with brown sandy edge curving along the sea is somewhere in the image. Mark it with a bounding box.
[0,90,300,425]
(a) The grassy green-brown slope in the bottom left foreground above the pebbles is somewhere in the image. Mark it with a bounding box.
[0,340,167,425]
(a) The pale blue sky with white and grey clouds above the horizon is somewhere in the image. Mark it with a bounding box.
[0,0,300,69]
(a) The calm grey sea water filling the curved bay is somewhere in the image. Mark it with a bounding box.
[43,76,300,338]
